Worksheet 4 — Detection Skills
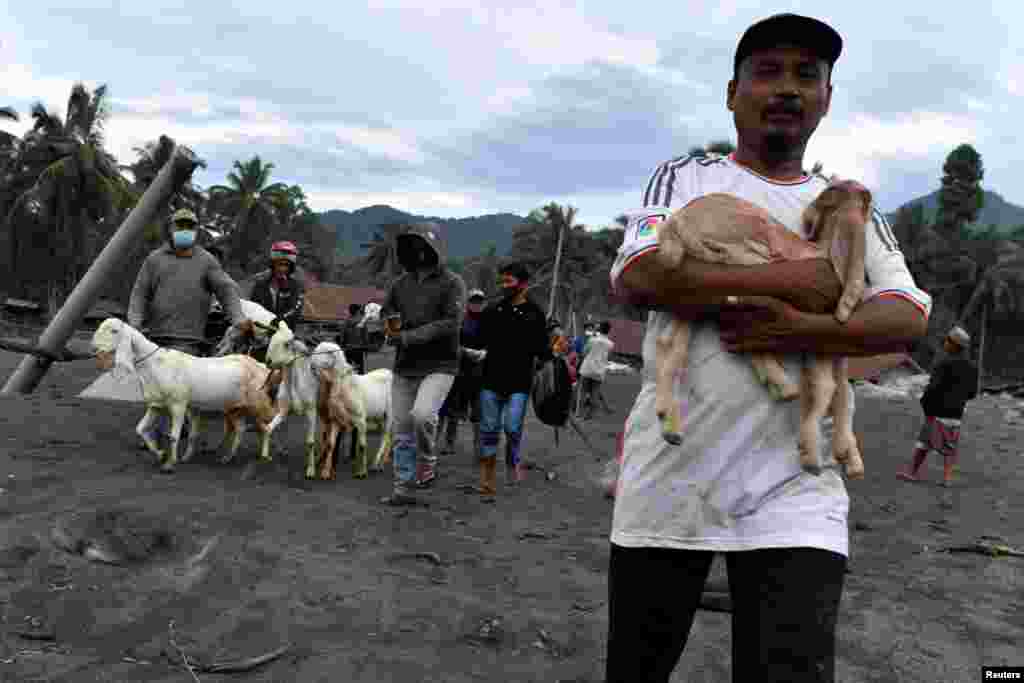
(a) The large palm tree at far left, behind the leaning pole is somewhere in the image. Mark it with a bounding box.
[8,83,131,315]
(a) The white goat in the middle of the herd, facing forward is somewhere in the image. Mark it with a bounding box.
[266,321,319,479]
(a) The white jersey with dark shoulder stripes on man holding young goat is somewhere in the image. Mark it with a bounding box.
[611,155,932,555]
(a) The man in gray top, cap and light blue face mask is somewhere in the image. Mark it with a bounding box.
[128,209,245,454]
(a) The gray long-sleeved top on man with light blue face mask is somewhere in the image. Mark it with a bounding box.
[128,245,243,341]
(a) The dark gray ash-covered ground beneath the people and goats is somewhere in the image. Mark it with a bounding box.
[0,339,1024,683]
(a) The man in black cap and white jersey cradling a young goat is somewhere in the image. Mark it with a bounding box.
[605,14,931,683]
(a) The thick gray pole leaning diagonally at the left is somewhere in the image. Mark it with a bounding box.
[0,146,199,395]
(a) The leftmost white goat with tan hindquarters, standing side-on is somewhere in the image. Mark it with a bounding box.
[92,317,273,472]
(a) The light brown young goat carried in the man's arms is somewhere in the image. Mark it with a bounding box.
[655,181,871,479]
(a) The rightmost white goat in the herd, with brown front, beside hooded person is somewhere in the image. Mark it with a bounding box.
[311,342,391,479]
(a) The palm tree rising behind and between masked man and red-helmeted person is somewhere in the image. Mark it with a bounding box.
[208,156,288,271]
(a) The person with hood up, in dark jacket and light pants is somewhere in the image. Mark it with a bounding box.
[381,222,466,505]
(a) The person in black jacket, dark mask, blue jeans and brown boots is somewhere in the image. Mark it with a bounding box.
[479,263,551,503]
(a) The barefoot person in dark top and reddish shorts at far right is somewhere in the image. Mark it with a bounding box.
[897,327,978,486]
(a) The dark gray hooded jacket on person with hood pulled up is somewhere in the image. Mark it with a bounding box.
[381,223,466,377]
